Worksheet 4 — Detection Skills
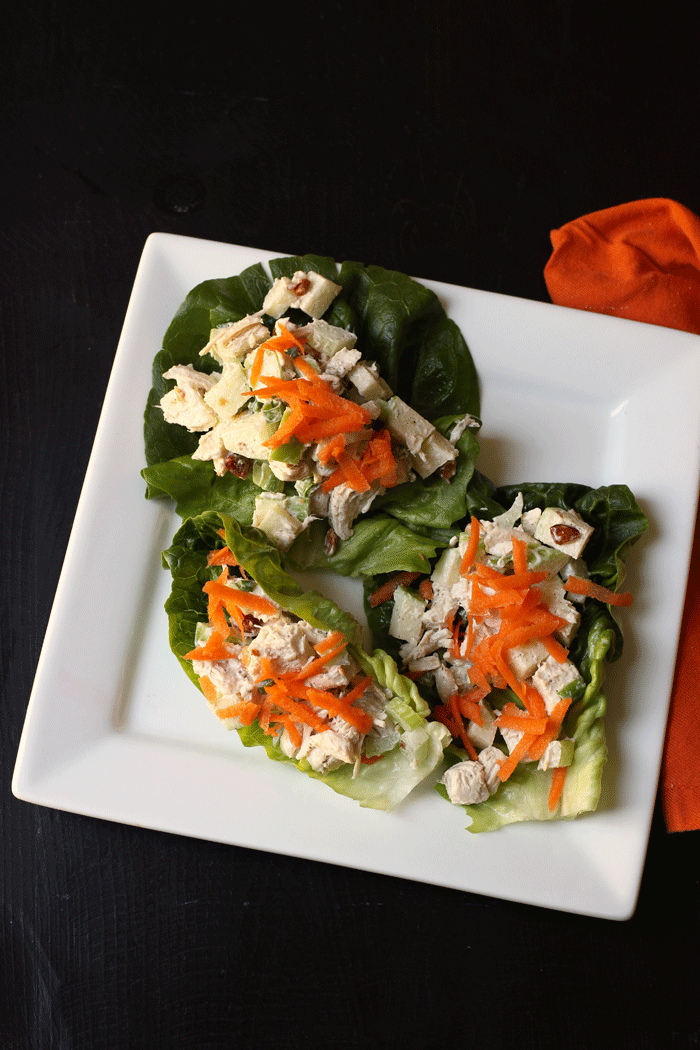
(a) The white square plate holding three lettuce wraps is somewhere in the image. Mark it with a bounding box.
[13,233,700,919]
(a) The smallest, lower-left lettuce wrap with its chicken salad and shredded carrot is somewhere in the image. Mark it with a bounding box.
[163,511,450,811]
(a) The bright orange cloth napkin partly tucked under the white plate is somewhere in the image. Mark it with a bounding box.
[545,197,700,832]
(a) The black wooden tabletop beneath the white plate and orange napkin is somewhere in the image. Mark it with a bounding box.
[0,0,700,1050]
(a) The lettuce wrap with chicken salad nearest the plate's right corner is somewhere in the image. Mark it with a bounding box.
[365,478,648,833]
